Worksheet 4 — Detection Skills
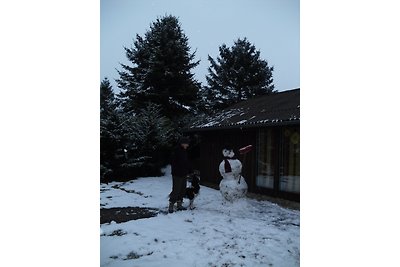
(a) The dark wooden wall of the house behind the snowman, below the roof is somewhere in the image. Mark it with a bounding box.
[192,125,300,201]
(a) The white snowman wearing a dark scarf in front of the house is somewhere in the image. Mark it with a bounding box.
[219,148,247,202]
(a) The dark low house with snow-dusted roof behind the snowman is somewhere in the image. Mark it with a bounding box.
[186,89,300,201]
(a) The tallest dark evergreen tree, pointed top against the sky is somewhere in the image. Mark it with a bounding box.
[117,15,200,126]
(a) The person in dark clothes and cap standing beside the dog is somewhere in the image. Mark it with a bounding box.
[168,137,193,213]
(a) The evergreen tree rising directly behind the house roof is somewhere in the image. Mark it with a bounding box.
[206,38,274,109]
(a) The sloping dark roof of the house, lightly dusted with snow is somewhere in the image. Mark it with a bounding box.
[188,88,300,131]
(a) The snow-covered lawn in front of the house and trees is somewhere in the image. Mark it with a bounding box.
[100,168,300,267]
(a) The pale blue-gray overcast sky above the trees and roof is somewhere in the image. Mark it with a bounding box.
[100,0,300,91]
